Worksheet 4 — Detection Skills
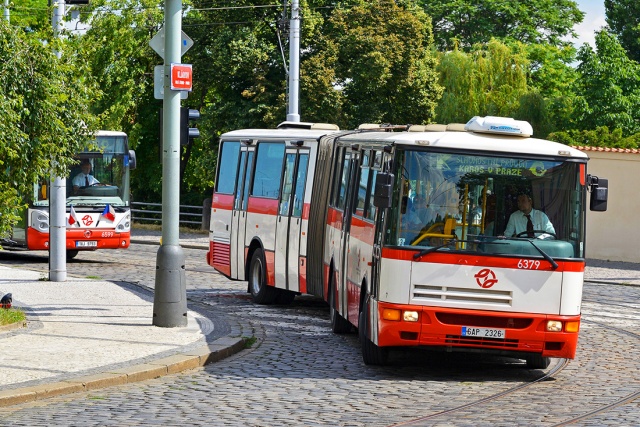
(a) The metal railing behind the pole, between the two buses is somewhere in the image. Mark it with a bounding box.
[131,199,211,230]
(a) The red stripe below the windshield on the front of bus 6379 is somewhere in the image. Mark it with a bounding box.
[382,248,584,273]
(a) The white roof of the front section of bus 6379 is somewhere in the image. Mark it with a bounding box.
[340,131,588,159]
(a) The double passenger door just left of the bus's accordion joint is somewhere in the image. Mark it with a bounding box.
[275,149,309,291]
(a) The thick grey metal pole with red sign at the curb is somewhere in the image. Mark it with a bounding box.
[153,0,187,328]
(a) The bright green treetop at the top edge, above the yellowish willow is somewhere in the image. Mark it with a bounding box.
[418,0,584,51]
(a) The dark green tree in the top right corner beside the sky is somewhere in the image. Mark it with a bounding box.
[604,0,640,61]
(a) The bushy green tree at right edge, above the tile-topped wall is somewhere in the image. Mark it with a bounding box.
[573,30,640,136]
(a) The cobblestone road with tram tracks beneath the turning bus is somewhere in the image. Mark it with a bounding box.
[0,241,640,426]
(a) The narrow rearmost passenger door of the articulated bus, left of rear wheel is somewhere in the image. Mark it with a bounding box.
[231,147,254,280]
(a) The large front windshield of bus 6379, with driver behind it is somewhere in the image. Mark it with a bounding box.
[385,147,586,258]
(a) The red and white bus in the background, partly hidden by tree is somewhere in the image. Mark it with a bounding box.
[0,130,136,259]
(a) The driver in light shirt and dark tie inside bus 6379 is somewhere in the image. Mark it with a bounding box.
[504,194,556,239]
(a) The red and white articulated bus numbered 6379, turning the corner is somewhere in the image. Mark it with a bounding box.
[207,117,607,369]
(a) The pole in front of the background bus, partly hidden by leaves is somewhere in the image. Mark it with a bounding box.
[49,0,67,282]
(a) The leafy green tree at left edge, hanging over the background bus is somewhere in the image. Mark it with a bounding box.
[0,21,95,235]
